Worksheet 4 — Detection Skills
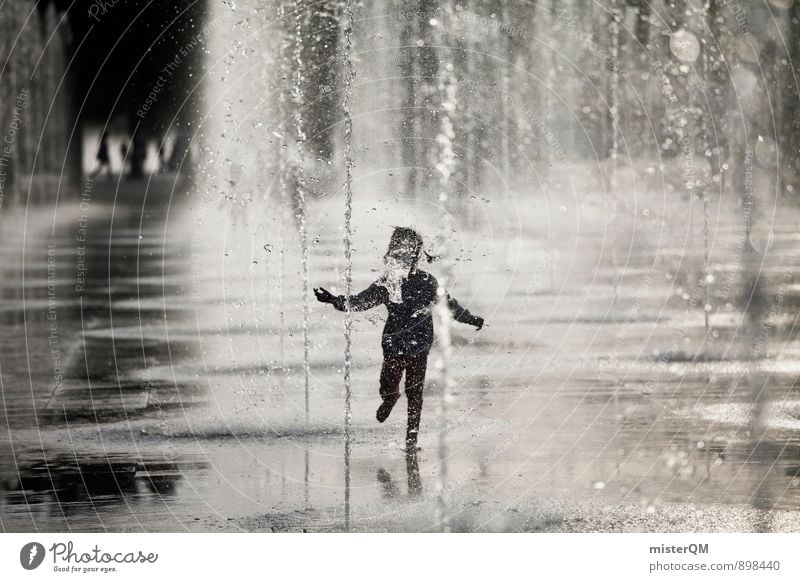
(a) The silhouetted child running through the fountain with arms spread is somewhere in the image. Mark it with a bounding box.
[314,227,483,451]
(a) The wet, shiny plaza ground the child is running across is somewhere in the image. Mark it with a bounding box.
[0,180,800,531]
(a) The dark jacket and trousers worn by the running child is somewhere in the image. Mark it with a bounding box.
[331,270,483,445]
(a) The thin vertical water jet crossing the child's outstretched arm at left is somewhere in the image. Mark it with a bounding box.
[342,0,355,531]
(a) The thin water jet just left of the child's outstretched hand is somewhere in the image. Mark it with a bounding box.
[292,0,310,422]
